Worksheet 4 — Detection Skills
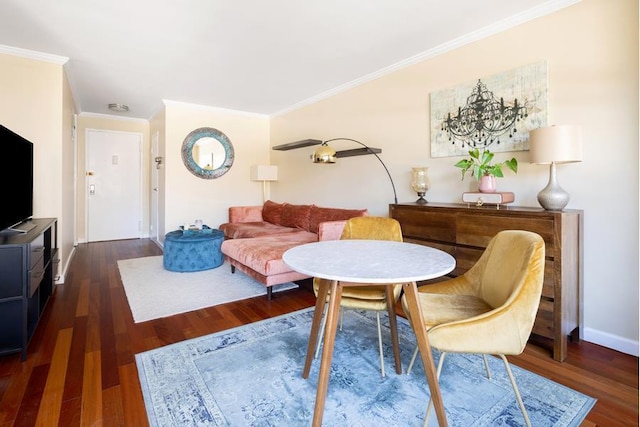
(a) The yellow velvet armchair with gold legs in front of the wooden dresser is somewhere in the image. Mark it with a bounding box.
[402,230,545,425]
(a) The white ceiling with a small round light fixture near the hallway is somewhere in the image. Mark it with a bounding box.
[0,0,578,119]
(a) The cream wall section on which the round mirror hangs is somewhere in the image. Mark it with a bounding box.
[160,102,269,241]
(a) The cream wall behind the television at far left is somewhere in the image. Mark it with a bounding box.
[0,51,75,284]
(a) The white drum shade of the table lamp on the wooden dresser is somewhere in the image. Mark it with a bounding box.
[529,125,582,164]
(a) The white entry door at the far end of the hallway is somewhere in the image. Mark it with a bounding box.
[86,129,142,242]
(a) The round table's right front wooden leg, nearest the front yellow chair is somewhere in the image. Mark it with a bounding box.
[402,282,447,427]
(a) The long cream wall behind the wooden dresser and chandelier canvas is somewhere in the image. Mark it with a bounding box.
[271,0,638,355]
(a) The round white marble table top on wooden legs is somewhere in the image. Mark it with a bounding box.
[282,240,456,283]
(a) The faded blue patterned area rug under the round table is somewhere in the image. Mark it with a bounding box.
[136,309,595,427]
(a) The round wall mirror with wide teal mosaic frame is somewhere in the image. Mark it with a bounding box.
[182,128,234,179]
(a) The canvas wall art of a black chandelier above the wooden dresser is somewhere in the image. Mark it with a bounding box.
[430,61,549,157]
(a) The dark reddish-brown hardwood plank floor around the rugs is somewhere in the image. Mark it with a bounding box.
[0,239,639,427]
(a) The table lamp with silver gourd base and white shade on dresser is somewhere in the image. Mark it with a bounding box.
[529,125,582,211]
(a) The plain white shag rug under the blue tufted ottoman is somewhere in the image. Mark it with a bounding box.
[118,255,298,323]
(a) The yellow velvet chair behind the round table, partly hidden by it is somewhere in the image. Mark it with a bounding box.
[313,216,402,377]
